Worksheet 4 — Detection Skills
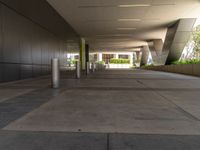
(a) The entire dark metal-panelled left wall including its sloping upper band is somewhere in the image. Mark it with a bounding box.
[0,0,79,82]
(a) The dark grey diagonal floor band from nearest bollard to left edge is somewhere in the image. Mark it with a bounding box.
[0,89,61,128]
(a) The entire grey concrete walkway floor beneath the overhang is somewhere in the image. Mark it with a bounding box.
[0,70,200,150]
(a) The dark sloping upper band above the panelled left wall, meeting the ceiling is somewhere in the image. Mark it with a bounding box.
[0,0,78,39]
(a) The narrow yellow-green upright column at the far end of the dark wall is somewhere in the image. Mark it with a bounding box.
[80,38,86,70]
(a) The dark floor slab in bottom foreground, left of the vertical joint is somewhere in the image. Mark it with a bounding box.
[0,131,107,150]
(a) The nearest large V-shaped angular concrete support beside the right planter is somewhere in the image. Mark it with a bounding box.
[147,18,196,65]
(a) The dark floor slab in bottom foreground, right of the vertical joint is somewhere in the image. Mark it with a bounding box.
[109,134,200,150]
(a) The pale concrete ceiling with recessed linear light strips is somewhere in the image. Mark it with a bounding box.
[47,0,200,50]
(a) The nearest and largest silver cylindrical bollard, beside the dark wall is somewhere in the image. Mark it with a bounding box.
[51,58,60,88]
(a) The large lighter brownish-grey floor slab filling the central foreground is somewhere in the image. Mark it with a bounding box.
[4,89,200,134]
